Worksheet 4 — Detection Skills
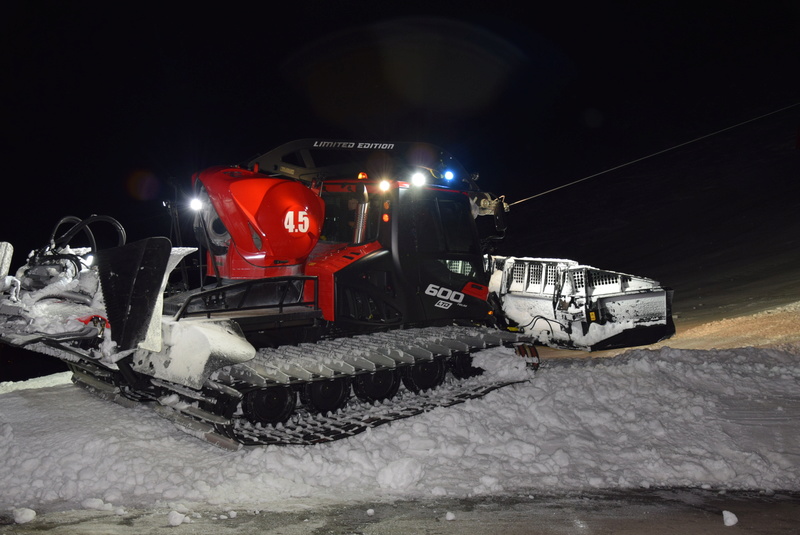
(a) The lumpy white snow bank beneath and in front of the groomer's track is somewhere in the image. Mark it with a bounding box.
[0,320,800,525]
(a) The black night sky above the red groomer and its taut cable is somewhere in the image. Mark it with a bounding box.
[0,0,800,263]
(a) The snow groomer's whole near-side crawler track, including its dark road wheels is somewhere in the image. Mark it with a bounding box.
[62,326,538,450]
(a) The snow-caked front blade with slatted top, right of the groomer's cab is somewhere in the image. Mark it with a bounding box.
[489,256,675,351]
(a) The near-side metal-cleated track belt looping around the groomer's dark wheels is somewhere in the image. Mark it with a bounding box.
[148,327,538,450]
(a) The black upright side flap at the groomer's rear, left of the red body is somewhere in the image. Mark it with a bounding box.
[97,237,172,351]
